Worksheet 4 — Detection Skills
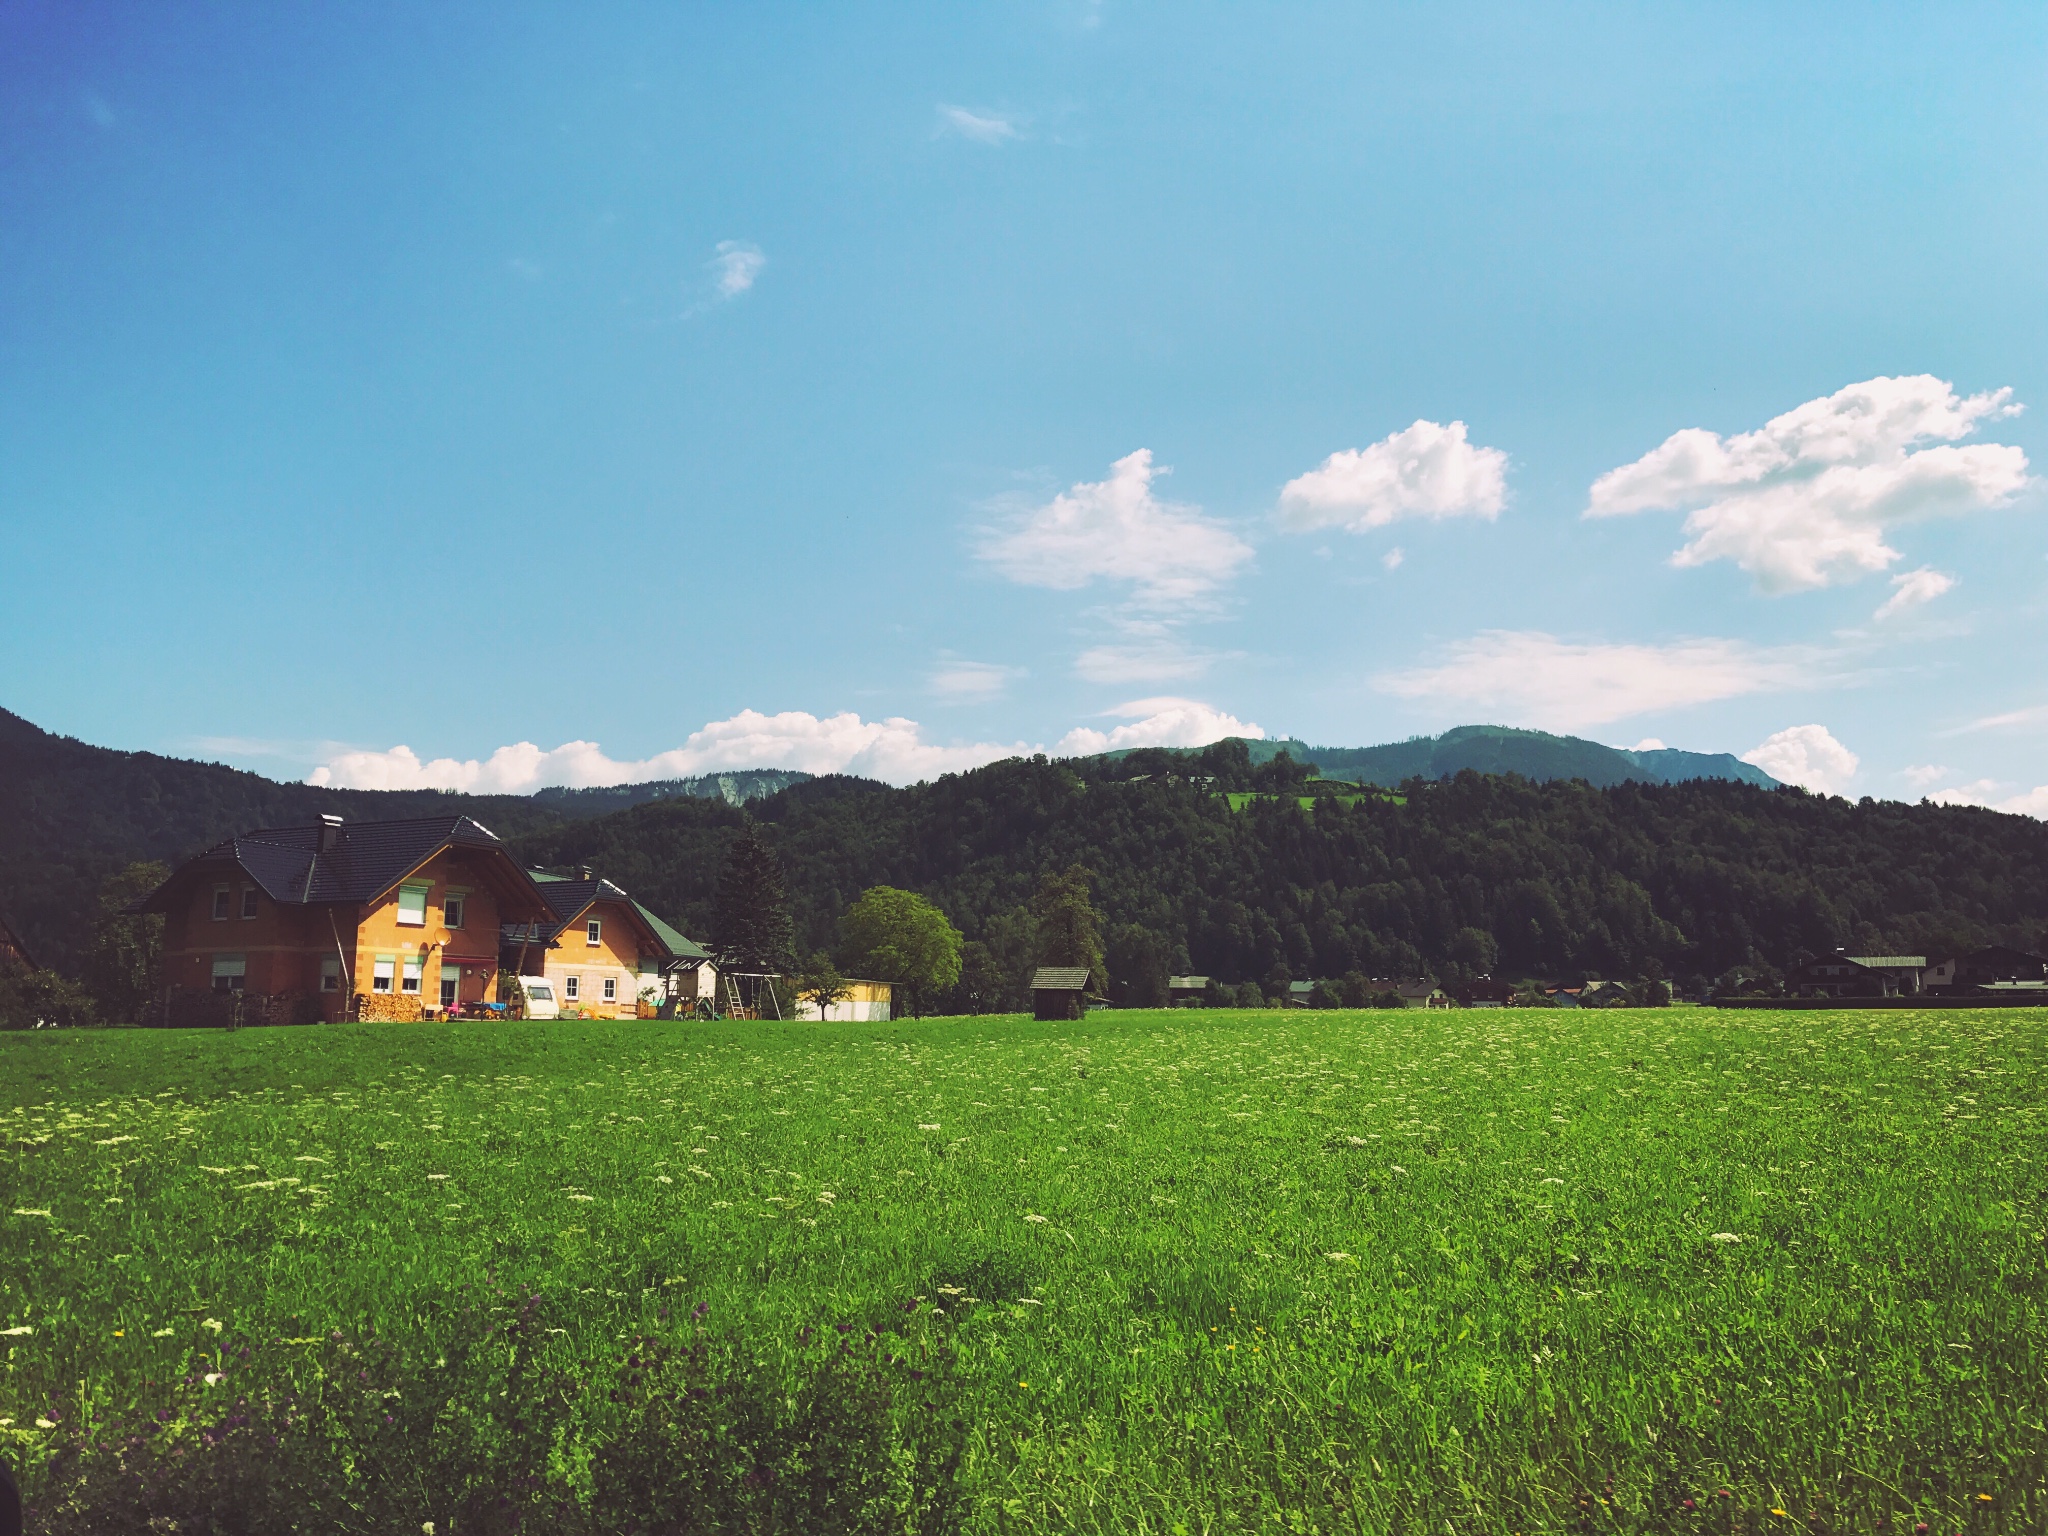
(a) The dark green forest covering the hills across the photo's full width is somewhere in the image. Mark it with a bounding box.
[0,713,2048,999]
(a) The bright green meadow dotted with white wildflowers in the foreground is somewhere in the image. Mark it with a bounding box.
[0,1010,2048,1536]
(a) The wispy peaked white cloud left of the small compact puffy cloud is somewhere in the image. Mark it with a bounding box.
[977,449,1251,610]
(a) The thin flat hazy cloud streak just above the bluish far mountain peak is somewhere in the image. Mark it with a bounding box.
[1374,629,1815,731]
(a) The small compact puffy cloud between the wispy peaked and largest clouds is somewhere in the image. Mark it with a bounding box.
[1280,422,1507,532]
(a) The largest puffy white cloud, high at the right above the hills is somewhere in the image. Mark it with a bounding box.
[1585,373,2028,592]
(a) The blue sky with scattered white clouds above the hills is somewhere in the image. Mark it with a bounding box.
[0,0,2048,813]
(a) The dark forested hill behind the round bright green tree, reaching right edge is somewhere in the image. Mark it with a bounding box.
[520,743,2048,1011]
